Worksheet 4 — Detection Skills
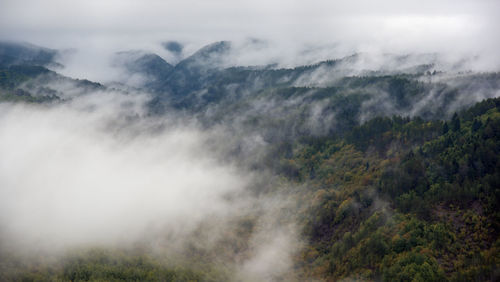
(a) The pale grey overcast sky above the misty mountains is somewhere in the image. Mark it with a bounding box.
[0,0,500,70]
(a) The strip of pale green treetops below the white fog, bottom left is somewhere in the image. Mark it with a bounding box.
[0,249,223,281]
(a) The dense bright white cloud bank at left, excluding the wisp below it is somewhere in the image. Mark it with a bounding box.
[0,90,244,247]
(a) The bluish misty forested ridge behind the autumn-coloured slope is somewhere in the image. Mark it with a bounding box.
[112,42,500,148]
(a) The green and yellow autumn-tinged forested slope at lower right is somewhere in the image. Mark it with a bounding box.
[289,98,500,281]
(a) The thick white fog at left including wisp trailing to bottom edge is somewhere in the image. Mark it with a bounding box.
[0,90,298,280]
